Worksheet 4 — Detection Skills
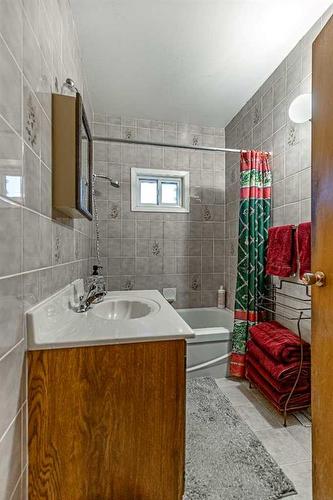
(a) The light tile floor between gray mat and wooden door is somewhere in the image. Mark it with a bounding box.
[216,378,312,500]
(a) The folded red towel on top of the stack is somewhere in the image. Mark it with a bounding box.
[250,321,311,363]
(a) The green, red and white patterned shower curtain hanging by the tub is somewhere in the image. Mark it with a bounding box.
[230,151,272,377]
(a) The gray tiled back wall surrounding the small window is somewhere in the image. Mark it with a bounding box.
[93,114,225,307]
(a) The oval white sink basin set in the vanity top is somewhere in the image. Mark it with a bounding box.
[91,297,160,321]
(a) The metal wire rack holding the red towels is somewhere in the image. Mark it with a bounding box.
[250,279,311,427]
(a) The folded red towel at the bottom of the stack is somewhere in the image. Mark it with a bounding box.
[246,363,311,410]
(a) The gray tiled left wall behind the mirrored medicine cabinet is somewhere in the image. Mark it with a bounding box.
[0,0,91,500]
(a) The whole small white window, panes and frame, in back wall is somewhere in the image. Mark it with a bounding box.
[131,168,190,212]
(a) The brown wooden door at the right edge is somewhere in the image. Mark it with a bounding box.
[312,12,333,500]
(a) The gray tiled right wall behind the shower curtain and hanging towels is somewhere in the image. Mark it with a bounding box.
[225,8,333,338]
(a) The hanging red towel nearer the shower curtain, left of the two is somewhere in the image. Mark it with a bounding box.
[266,224,297,278]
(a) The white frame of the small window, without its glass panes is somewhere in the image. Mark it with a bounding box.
[131,167,190,213]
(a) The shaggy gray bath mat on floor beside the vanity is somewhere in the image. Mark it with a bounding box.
[186,377,296,500]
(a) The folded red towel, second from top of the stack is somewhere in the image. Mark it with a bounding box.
[246,339,311,385]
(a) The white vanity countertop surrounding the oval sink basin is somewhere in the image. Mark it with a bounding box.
[26,280,194,350]
